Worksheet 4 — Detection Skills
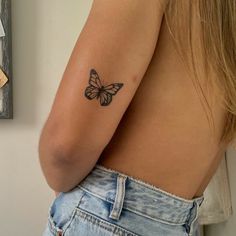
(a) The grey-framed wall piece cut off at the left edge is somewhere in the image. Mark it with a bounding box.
[0,0,13,119]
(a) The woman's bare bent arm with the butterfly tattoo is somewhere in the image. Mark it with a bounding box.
[39,0,167,192]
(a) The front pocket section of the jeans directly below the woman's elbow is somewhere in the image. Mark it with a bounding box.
[45,188,85,236]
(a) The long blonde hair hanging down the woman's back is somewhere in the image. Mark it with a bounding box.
[165,0,236,148]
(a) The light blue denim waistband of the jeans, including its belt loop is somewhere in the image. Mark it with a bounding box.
[78,164,204,227]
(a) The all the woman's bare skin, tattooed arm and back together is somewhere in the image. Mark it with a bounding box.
[39,0,229,199]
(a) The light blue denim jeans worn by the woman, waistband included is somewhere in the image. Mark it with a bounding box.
[43,164,204,236]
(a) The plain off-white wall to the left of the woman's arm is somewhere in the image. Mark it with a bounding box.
[0,0,92,236]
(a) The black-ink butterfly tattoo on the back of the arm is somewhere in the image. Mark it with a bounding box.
[84,69,123,106]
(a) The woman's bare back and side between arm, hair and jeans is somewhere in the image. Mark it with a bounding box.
[98,17,228,199]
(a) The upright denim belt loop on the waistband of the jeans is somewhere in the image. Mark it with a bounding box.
[109,173,127,220]
